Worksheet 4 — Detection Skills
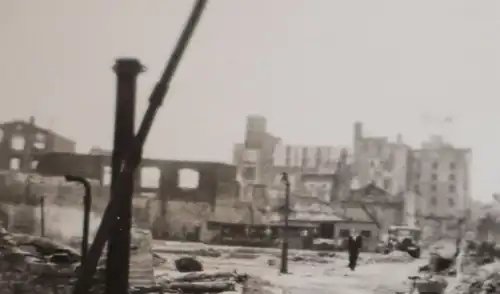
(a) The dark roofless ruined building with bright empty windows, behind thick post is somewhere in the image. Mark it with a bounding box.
[37,153,238,237]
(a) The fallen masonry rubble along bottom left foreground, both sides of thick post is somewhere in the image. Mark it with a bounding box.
[0,231,262,294]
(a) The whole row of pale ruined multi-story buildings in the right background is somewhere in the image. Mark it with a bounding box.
[234,116,471,231]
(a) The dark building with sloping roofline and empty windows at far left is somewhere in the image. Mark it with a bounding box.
[0,117,76,172]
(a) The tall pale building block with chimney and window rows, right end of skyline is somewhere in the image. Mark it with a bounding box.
[354,122,472,222]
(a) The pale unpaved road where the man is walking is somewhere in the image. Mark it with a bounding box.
[155,242,425,294]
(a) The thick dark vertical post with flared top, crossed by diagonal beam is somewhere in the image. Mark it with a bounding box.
[106,58,142,294]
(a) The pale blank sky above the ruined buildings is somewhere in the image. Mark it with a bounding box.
[0,0,500,199]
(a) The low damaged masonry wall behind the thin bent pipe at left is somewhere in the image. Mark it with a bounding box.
[0,171,107,239]
